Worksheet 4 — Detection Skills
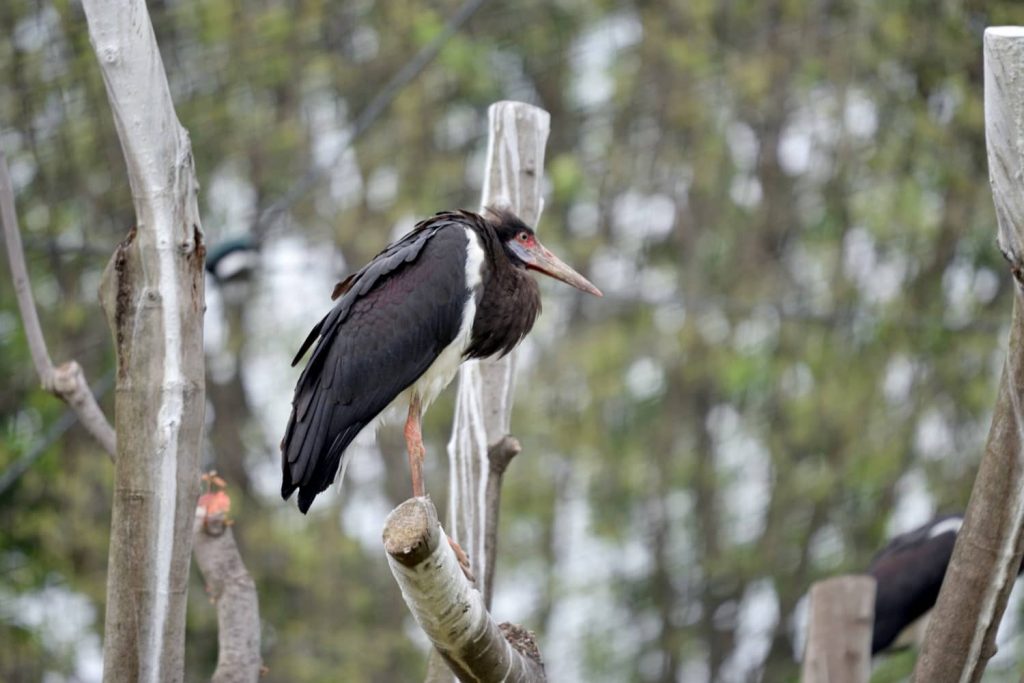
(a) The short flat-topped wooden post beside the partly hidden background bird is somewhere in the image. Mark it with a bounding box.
[800,575,876,683]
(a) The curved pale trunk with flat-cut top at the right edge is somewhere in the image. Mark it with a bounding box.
[914,27,1024,683]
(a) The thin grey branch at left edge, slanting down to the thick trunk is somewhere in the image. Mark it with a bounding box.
[0,152,117,458]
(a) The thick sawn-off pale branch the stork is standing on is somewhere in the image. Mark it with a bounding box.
[383,498,546,683]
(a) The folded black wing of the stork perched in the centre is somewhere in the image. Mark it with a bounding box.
[281,214,470,512]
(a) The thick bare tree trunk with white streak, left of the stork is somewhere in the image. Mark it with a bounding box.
[83,0,205,682]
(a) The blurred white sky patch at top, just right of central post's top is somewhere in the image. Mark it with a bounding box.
[570,11,643,109]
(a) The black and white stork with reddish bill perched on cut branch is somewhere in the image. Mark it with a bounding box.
[281,211,601,512]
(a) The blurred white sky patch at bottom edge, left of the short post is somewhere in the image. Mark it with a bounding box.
[720,579,779,683]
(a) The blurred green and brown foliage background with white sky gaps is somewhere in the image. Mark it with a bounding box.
[0,0,1024,683]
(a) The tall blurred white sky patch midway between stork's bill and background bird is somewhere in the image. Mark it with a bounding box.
[708,403,771,544]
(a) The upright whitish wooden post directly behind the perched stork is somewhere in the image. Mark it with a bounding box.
[447,101,551,596]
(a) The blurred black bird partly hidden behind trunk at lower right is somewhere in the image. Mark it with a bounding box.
[867,515,1024,654]
